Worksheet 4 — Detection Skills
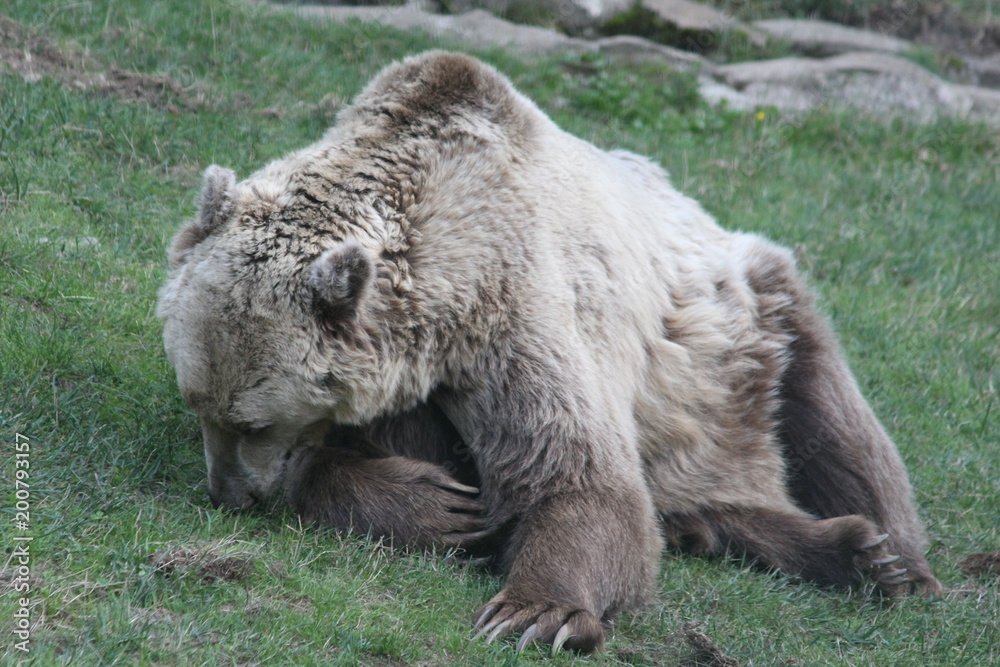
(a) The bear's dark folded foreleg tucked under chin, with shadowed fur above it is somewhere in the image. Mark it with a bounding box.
[285,403,489,554]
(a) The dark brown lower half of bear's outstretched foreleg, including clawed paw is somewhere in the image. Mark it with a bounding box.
[475,489,660,652]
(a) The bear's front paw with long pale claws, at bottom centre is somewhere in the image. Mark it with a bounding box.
[473,591,604,654]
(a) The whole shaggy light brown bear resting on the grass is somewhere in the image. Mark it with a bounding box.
[159,52,939,650]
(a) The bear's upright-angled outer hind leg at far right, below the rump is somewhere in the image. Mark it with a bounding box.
[747,247,941,596]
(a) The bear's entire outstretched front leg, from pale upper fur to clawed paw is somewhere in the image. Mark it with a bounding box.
[436,366,661,651]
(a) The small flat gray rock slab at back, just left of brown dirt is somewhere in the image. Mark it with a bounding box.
[753,19,913,56]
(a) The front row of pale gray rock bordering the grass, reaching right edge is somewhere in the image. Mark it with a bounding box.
[276,5,1000,125]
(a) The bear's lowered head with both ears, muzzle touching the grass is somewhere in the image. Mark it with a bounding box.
[157,166,377,508]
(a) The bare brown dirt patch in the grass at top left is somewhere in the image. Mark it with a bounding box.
[0,15,206,111]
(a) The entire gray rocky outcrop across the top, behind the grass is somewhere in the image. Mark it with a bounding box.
[274,0,1000,126]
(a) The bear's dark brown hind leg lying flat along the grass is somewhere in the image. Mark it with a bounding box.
[661,508,906,587]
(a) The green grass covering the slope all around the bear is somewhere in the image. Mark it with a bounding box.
[0,0,1000,665]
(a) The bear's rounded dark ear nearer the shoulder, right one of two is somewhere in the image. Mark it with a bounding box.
[309,241,375,324]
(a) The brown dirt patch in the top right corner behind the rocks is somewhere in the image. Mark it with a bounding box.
[862,0,1000,56]
